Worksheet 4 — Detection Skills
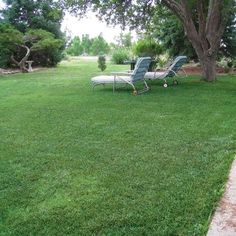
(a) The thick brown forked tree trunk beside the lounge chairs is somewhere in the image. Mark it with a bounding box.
[162,0,228,81]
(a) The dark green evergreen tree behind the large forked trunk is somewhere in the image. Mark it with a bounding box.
[148,6,236,60]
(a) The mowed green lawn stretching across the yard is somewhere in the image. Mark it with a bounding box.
[0,57,236,236]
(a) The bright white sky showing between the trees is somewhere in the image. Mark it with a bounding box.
[0,0,136,43]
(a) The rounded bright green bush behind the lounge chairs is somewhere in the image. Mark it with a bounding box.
[133,38,162,58]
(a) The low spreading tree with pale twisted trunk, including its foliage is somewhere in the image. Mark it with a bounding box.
[0,24,64,72]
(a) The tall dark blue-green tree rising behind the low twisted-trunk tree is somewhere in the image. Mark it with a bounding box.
[2,0,63,38]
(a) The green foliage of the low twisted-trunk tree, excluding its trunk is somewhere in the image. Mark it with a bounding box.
[0,24,64,67]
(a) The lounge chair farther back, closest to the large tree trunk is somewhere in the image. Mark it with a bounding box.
[144,56,187,88]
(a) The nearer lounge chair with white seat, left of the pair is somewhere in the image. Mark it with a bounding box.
[91,57,151,95]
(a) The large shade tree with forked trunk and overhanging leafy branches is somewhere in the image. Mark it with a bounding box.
[62,0,235,81]
